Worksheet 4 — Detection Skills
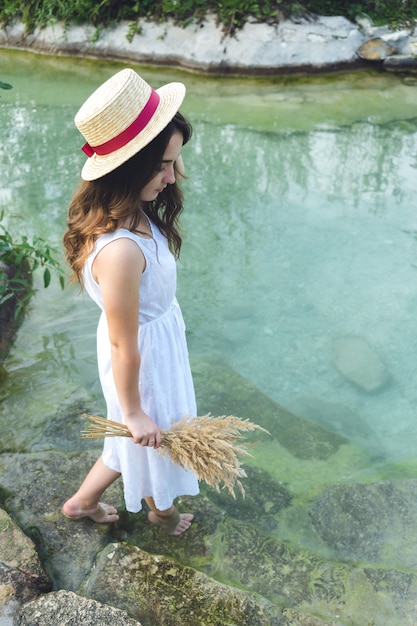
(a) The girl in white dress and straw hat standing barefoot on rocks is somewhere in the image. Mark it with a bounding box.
[63,69,198,535]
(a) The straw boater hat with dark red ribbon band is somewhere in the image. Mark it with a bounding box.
[74,69,185,180]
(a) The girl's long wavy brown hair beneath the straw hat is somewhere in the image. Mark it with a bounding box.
[63,112,192,285]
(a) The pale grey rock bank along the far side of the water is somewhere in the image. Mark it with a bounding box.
[0,16,417,75]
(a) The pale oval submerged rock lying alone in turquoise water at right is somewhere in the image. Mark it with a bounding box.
[333,335,391,393]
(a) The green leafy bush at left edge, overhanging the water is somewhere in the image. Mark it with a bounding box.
[0,212,65,319]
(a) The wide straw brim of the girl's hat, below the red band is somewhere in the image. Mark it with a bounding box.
[81,83,185,180]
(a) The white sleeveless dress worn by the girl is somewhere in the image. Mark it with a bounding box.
[83,224,199,513]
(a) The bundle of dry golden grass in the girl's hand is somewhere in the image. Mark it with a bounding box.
[82,414,269,497]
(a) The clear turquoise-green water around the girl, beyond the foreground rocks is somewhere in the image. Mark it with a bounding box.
[0,51,417,616]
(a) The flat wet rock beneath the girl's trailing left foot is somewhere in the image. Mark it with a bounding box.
[0,451,123,591]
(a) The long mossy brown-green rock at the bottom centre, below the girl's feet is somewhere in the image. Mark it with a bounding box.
[81,543,281,626]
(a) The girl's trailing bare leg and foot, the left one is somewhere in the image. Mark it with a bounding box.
[62,457,120,524]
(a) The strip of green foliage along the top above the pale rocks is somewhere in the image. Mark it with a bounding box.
[0,0,417,32]
